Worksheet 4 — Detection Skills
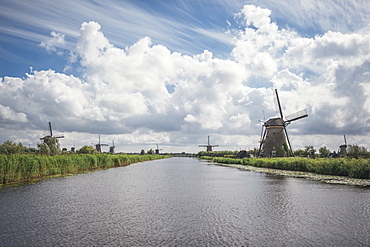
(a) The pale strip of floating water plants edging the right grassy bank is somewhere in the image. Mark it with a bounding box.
[203,157,370,187]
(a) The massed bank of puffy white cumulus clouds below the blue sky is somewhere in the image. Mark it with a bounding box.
[0,5,370,151]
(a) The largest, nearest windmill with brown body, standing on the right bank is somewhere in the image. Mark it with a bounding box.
[258,89,308,157]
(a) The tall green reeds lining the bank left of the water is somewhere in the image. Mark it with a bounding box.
[0,154,169,185]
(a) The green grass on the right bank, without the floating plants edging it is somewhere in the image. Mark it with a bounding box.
[201,156,370,179]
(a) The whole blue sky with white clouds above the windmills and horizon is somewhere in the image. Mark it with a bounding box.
[0,0,370,153]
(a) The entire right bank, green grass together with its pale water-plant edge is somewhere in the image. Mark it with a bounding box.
[201,156,370,186]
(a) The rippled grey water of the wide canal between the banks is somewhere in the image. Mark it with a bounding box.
[0,158,370,246]
